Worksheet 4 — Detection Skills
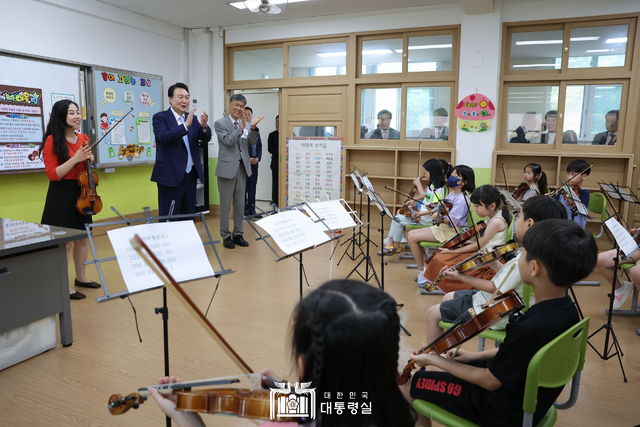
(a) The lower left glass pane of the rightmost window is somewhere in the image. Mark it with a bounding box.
[507,86,559,144]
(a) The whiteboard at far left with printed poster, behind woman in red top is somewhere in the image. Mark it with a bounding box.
[0,55,81,174]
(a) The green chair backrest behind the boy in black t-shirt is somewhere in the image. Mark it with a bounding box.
[522,317,590,414]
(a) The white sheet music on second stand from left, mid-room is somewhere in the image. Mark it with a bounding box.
[256,210,329,255]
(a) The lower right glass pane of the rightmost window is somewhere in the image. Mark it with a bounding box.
[562,84,622,145]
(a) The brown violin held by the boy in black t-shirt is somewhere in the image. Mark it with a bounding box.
[398,289,525,385]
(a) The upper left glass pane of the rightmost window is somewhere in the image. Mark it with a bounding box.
[511,30,562,70]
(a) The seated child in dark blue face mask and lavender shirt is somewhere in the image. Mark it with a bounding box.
[407,165,476,278]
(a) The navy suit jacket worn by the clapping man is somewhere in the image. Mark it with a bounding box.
[151,107,211,187]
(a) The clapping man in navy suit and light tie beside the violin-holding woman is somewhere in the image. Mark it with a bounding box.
[151,83,211,216]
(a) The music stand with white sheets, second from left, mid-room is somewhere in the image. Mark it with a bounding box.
[245,202,340,300]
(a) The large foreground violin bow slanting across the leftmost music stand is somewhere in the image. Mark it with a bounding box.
[131,234,254,374]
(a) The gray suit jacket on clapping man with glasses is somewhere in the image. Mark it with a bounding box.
[213,116,260,179]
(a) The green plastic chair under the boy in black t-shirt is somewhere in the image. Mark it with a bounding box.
[413,317,589,427]
